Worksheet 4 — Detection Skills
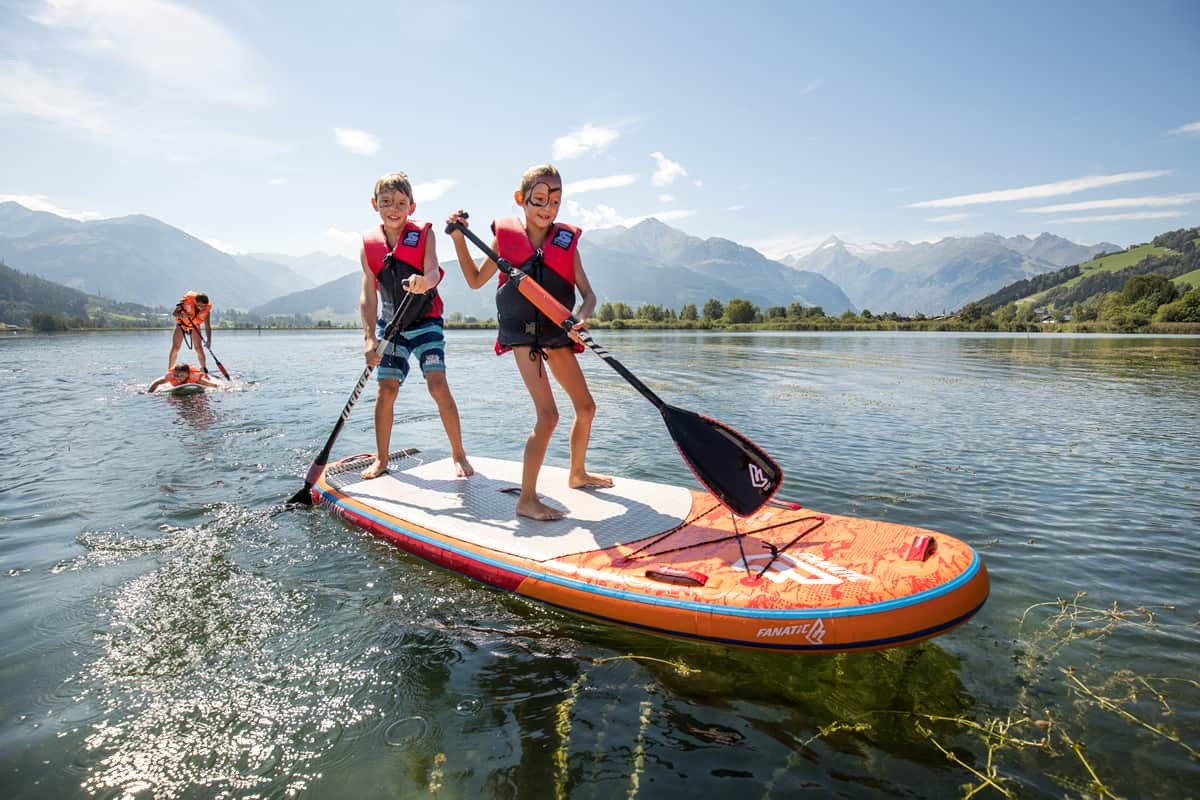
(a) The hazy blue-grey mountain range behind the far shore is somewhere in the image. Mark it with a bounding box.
[0,201,1121,321]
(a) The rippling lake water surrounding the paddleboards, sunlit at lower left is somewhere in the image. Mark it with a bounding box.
[0,331,1200,800]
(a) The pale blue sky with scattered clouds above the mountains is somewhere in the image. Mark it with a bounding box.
[0,0,1200,277]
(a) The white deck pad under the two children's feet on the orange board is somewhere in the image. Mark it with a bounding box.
[326,452,691,561]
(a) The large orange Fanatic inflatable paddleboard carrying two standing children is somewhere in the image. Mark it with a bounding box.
[312,450,989,652]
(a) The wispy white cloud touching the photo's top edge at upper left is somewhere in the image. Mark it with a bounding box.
[29,0,270,107]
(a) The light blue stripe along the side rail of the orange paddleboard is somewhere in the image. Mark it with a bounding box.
[317,487,982,624]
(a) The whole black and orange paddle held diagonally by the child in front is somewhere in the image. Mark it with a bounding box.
[446,215,784,517]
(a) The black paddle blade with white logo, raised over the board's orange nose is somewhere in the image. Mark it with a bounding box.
[661,405,784,517]
